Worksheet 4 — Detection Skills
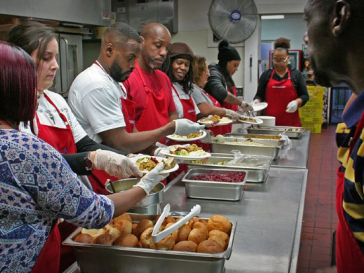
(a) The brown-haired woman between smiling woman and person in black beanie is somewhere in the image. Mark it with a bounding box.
[191,55,240,136]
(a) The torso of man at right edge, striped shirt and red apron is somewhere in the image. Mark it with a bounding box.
[336,92,364,273]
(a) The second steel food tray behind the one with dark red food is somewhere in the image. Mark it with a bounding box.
[210,137,282,159]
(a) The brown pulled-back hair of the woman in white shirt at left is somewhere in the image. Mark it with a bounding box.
[8,21,57,68]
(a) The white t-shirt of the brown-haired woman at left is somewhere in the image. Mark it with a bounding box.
[19,90,87,143]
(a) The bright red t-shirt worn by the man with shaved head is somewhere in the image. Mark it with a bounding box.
[123,69,176,122]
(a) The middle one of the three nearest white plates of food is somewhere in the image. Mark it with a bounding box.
[160,144,211,160]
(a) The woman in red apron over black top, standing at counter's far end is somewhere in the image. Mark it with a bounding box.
[253,38,308,127]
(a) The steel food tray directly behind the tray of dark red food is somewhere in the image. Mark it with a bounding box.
[186,153,272,183]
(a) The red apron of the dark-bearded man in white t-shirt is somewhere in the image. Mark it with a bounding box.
[88,62,135,195]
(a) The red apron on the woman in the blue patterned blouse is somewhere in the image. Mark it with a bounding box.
[32,223,62,273]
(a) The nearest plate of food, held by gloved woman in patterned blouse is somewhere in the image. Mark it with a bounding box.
[130,155,179,174]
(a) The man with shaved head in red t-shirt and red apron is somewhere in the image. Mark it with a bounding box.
[124,23,178,141]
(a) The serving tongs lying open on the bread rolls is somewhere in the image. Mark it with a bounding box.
[152,204,201,243]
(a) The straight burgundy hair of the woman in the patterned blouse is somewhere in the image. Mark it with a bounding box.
[0,41,37,124]
